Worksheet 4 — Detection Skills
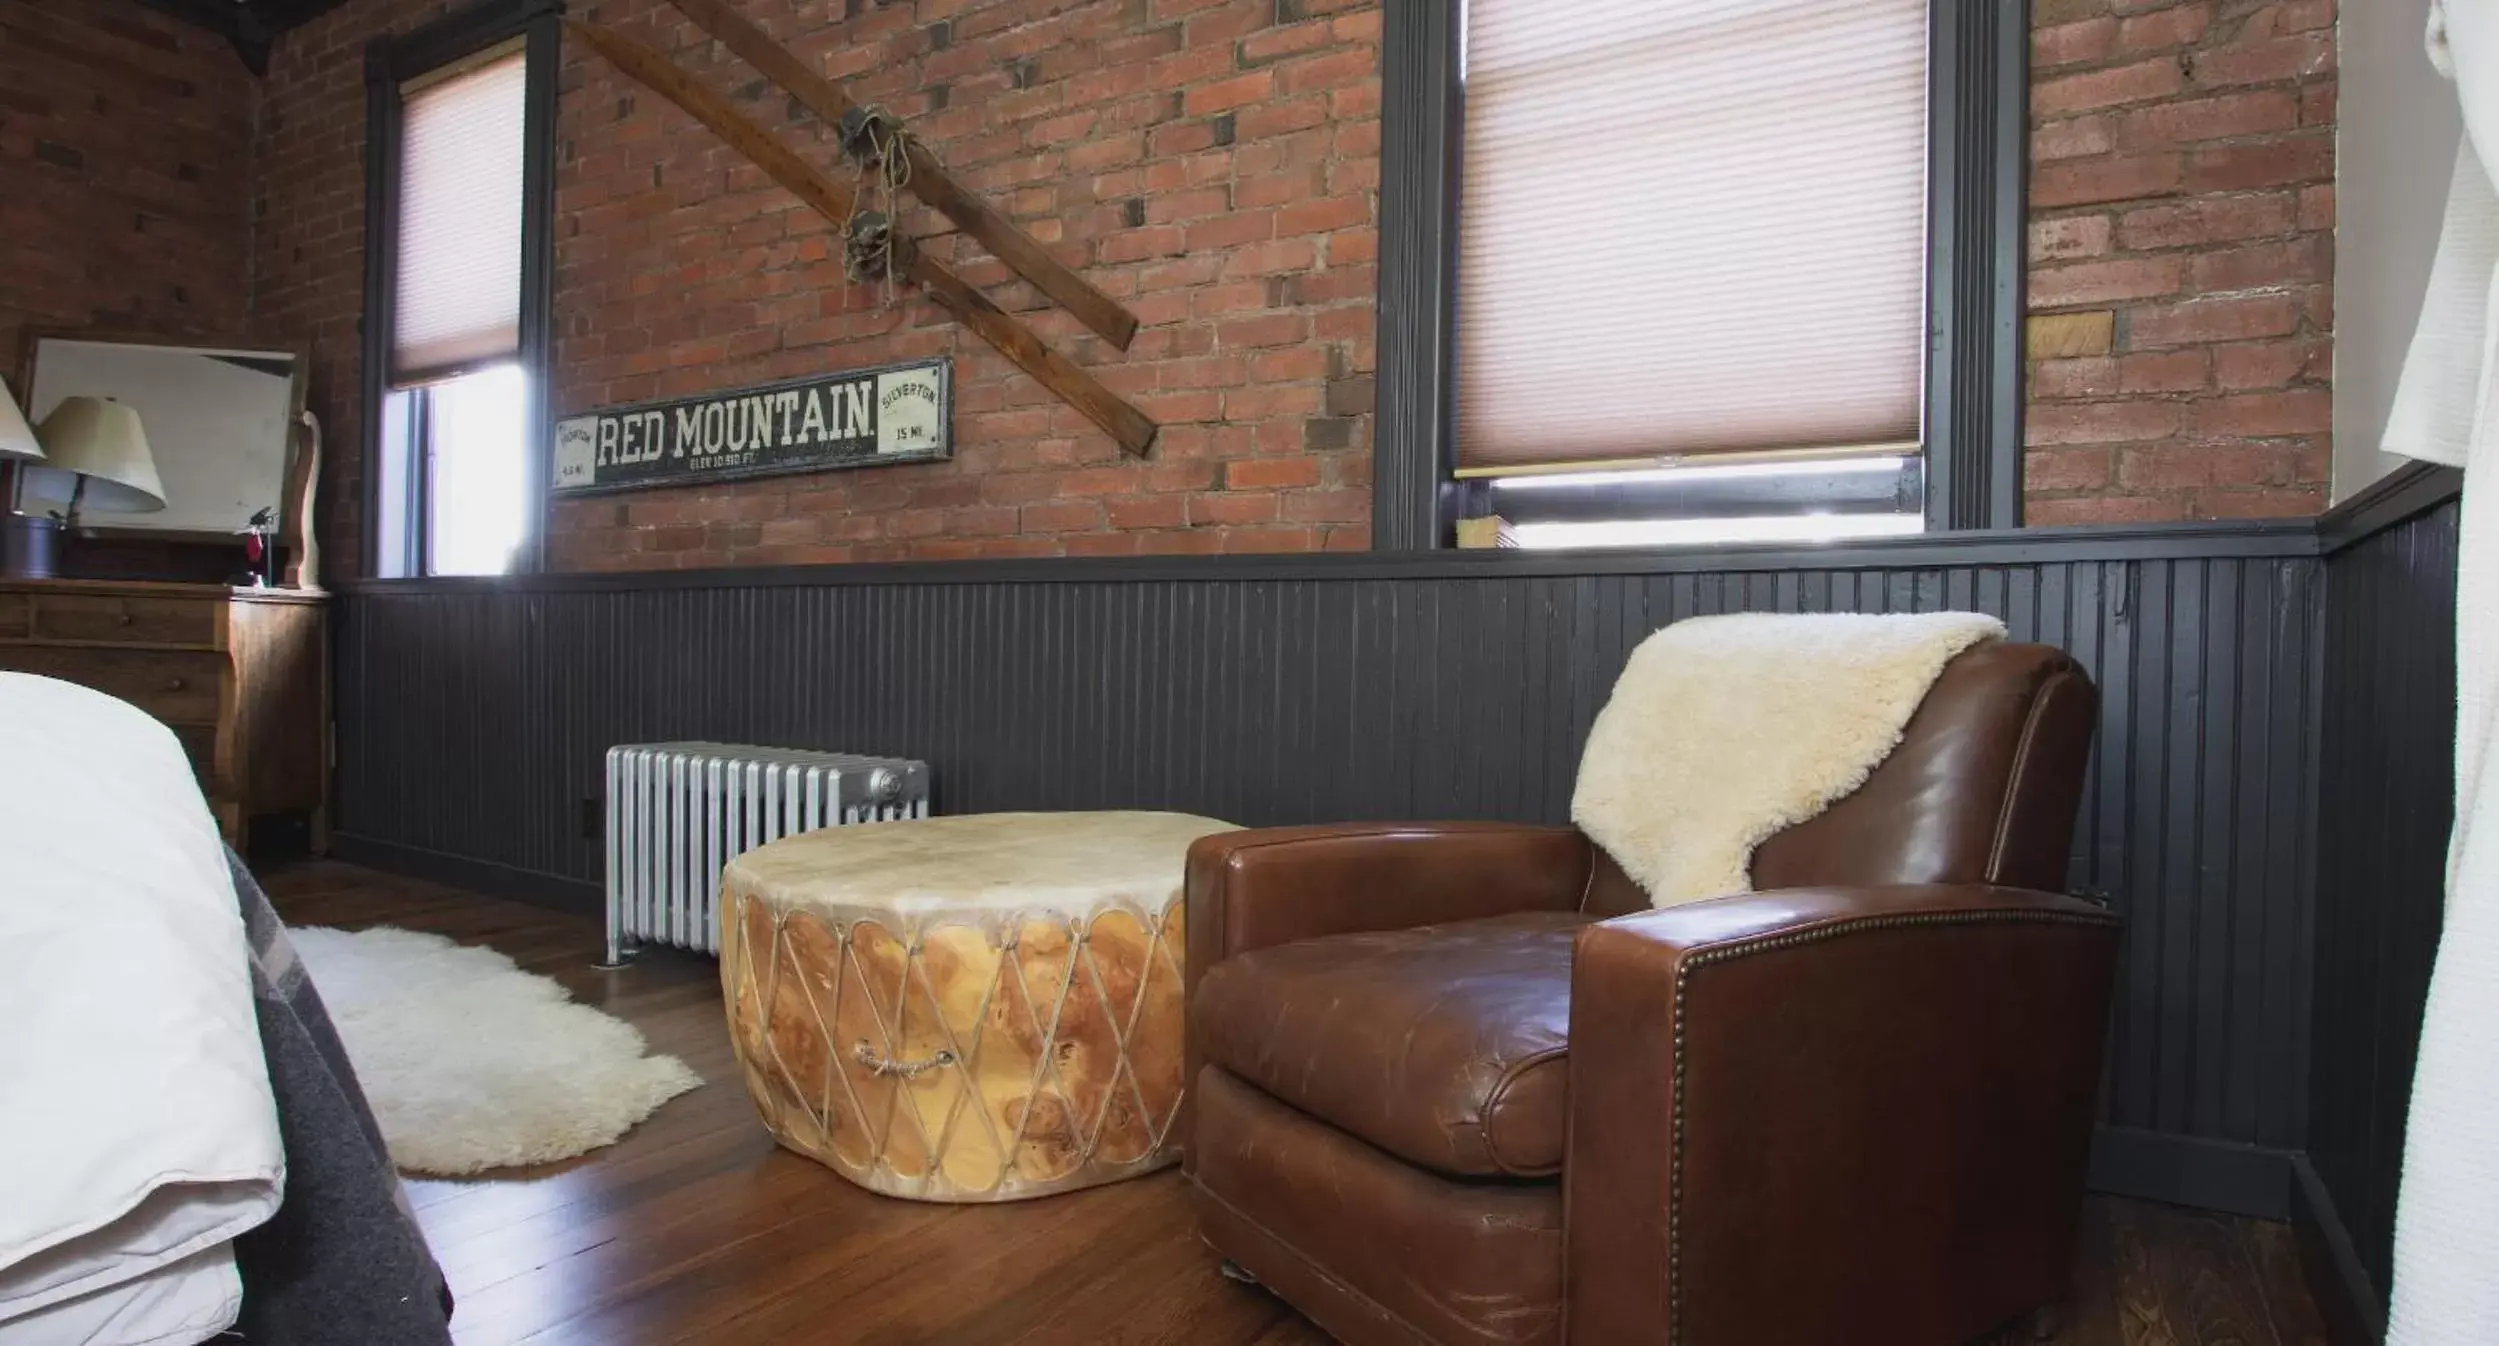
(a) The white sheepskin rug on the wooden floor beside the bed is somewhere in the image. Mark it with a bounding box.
[287,926,702,1176]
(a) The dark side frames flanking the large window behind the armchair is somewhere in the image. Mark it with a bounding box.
[1372,0,2029,552]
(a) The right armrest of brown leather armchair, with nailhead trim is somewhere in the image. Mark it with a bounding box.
[1564,884,2117,1344]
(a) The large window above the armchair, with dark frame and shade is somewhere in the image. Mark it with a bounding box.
[1374,0,2024,547]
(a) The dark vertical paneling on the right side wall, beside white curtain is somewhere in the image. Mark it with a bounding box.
[2307,499,2457,1309]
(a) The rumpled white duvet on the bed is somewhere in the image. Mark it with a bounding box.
[0,674,285,1346]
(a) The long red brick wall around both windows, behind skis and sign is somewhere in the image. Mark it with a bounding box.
[255,0,2334,572]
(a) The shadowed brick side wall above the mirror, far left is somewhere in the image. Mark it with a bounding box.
[0,0,257,367]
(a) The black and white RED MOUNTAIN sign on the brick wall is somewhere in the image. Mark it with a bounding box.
[552,360,955,494]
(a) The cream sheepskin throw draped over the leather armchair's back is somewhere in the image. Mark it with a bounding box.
[1569,612,2004,906]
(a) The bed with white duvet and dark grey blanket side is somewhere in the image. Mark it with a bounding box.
[0,674,447,1346]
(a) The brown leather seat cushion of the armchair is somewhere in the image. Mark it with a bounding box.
[1190,911,1589,1179]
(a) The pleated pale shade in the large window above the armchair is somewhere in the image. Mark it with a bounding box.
[1457,0,1929,469]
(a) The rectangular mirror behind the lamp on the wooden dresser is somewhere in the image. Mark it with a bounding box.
[17,332,305,539]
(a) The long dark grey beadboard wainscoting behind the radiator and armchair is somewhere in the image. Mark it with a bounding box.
[337,522,2324,1214]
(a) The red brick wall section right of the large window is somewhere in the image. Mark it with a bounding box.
[2027,0,2334,524]
